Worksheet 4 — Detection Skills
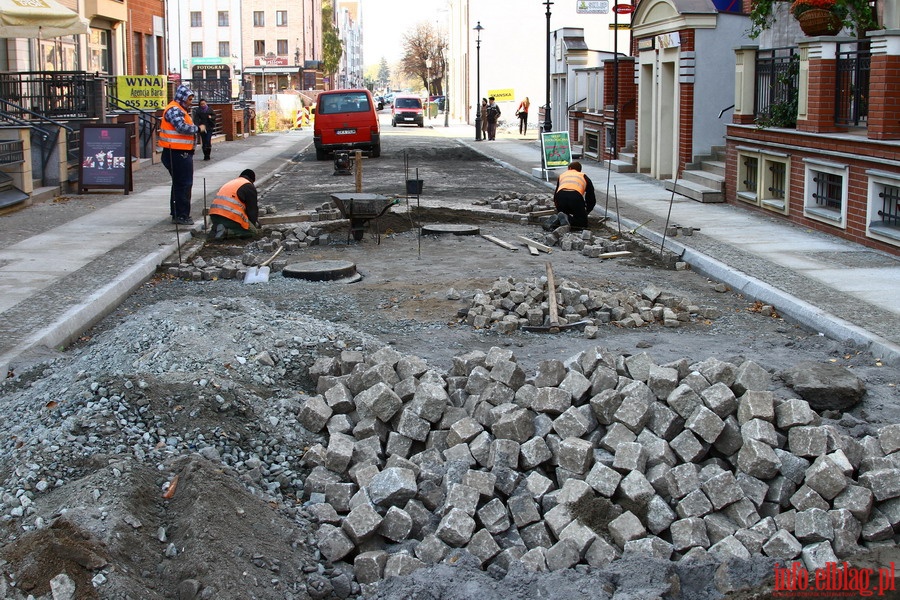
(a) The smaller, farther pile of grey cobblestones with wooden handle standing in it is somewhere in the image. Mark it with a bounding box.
[460,277,721,339]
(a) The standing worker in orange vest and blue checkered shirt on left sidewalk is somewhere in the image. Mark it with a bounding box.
[159,85,206,225]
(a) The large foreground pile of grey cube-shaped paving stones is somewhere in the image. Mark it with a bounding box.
[298,347,900,584]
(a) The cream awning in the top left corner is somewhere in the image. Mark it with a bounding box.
[0,0,90,38]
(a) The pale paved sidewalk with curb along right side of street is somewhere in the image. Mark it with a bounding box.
[465,132,900,365]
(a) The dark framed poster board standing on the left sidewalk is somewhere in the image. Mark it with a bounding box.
[78,123,134,196]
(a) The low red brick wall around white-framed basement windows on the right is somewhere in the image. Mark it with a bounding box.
[725,126,900,255]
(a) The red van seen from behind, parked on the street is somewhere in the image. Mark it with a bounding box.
[313,90,381,160]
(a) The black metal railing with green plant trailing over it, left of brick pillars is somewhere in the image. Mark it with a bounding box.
[754,48,800,127]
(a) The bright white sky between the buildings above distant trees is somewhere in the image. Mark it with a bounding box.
[362,0,447,66]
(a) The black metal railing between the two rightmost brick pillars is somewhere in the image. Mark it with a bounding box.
[834,40,872,126]
